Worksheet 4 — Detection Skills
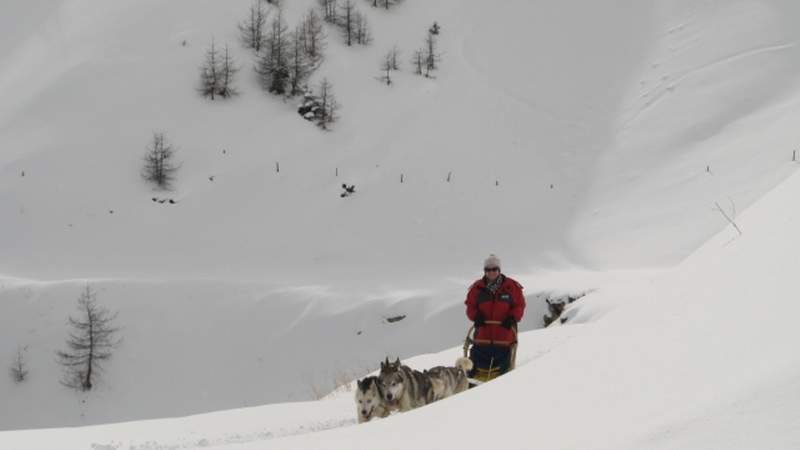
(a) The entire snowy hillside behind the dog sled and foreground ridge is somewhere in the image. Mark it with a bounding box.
[0,0,800,438]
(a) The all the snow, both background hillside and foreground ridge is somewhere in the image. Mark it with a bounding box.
[0,0,800,449]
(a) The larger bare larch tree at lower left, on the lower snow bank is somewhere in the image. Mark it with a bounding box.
[57,285,119,391]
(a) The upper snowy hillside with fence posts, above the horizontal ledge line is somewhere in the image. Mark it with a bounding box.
[0,0,800,283]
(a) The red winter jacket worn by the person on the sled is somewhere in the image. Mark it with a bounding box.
[464,275,525,345]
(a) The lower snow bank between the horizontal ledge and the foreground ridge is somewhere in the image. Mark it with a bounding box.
[0,280,544,430]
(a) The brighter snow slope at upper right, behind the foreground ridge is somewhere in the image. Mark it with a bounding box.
[572,0,800,266]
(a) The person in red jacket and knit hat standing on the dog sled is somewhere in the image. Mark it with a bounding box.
[464,255,525,379]
